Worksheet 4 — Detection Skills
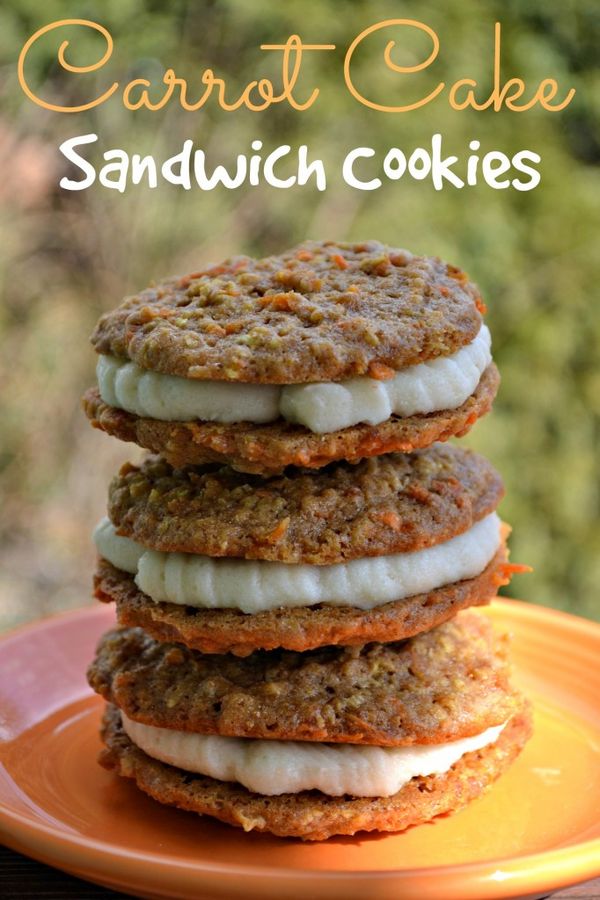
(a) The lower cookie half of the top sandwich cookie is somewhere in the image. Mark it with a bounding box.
[83,363,500,475]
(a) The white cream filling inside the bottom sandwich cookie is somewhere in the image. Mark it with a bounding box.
[121,712,506,797]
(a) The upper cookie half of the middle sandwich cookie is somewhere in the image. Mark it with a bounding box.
[108,445,503,565]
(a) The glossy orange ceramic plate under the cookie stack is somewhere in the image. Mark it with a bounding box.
[0,601,600,900]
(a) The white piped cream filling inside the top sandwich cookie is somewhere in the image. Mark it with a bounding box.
[96,325,492,434]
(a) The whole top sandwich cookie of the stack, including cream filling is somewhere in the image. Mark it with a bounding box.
[84,241,498,474]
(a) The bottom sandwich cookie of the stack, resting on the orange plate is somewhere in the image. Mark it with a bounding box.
[88,610,530,840]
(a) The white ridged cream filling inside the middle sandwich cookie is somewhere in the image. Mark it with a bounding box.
[94,513,501,613]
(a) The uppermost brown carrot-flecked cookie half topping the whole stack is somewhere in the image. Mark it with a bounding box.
[92,241,483,384]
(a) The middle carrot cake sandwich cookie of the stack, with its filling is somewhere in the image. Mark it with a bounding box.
[90,444,511,656]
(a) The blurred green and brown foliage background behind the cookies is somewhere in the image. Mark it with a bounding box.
[0,0,600,627]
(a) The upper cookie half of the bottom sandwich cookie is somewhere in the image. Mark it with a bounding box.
[88,611,518,746]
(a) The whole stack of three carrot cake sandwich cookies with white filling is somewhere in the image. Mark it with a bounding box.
[84,242,531,840]
